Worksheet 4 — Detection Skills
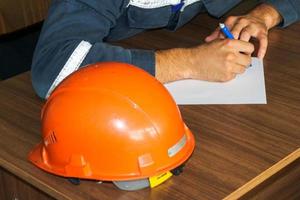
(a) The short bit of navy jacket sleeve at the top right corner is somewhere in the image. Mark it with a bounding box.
[262,0,300,27]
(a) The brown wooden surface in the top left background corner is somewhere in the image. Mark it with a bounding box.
[0,0,50,35]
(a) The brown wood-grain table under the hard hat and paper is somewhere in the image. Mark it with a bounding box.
[0,3,300,200]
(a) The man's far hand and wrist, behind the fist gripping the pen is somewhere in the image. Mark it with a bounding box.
[205,4,282,59]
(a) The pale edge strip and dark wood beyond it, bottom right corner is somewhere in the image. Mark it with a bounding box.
[224,148,300,200]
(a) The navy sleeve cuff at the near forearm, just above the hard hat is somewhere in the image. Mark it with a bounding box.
[131,49,155,76]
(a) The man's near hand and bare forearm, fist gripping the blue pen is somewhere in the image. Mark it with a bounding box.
[156,39,254,83]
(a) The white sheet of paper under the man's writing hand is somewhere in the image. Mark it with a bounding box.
[165,58,267,105]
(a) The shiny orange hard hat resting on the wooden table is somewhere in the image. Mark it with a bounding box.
[29,62,195,188]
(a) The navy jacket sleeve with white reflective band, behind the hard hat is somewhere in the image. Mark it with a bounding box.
[31,0,155,98]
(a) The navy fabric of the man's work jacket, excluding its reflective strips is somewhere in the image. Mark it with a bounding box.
[32,0,300,98]
